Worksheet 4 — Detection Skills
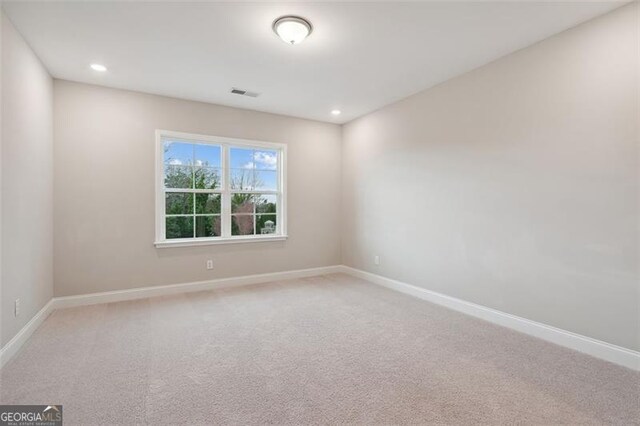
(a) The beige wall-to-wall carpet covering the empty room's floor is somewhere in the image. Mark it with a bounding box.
[0,274,640,425]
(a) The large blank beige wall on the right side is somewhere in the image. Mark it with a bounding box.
[342,3,640,350]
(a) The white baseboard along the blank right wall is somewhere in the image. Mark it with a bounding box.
[342,266,640,371]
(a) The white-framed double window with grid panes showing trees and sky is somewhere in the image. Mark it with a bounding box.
[155,130,286,247]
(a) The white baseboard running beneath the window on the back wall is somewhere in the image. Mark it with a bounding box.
[53,265,342,309]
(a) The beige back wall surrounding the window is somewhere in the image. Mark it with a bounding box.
[54,80,341,296]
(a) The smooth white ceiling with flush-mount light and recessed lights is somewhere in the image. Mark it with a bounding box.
[3,1,622,123]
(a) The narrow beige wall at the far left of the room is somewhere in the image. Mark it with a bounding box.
[0,13,53,345]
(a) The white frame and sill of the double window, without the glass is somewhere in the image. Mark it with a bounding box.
[154,129,287,248]
